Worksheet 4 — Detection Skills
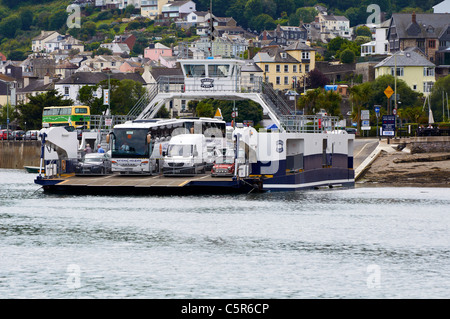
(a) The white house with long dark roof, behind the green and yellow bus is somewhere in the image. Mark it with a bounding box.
[55,72,146,104]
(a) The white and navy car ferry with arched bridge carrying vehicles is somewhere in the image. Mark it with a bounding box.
[35,52,355,194]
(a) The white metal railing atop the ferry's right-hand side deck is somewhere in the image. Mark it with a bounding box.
[280,115,339,133]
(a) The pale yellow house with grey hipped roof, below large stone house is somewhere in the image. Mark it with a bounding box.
[375,48,436,95]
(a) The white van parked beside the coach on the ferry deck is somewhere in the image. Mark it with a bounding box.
[163,134,208,176]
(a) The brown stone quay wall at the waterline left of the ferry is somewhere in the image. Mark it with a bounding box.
[0,141,41,169]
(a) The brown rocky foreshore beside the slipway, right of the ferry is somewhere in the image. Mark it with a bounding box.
[356,147,450,187]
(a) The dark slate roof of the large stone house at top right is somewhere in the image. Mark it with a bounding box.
[391,13,450,39]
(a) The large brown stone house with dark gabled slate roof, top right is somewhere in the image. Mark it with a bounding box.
[388,12,450,65]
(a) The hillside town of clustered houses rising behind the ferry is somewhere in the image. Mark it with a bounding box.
[0,0,450,132]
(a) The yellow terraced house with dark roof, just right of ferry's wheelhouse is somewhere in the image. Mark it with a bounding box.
[253,41,315,90]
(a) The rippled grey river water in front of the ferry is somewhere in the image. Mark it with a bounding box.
[0,169,450,299]
